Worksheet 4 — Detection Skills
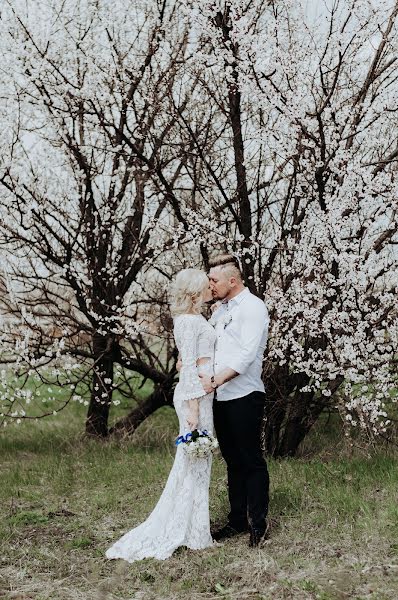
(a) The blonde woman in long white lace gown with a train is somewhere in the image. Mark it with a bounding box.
[106,269,216,562]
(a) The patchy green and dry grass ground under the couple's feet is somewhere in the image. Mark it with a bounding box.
[0,396,398,600]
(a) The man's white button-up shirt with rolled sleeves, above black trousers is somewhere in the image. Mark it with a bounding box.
[210,288,269,400]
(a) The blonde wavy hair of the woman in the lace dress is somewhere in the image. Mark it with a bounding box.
[170,269,209,317]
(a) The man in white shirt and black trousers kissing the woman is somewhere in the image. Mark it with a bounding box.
[201,254,269,547]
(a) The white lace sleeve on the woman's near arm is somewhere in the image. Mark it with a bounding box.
[174,317,206,400]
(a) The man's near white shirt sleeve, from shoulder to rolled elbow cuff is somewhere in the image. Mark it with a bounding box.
[227,302,269,375]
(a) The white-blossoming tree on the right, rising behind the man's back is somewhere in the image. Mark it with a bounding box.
[173,0,398,455]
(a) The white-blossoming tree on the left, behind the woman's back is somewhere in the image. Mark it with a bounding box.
[0,1,193,436]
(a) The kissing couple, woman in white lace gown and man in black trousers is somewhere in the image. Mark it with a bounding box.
[106,254,269,562]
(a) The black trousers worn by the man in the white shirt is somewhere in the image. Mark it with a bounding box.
[213,392,269,531]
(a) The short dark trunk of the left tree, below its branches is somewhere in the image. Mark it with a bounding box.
[86,334,114,438]
